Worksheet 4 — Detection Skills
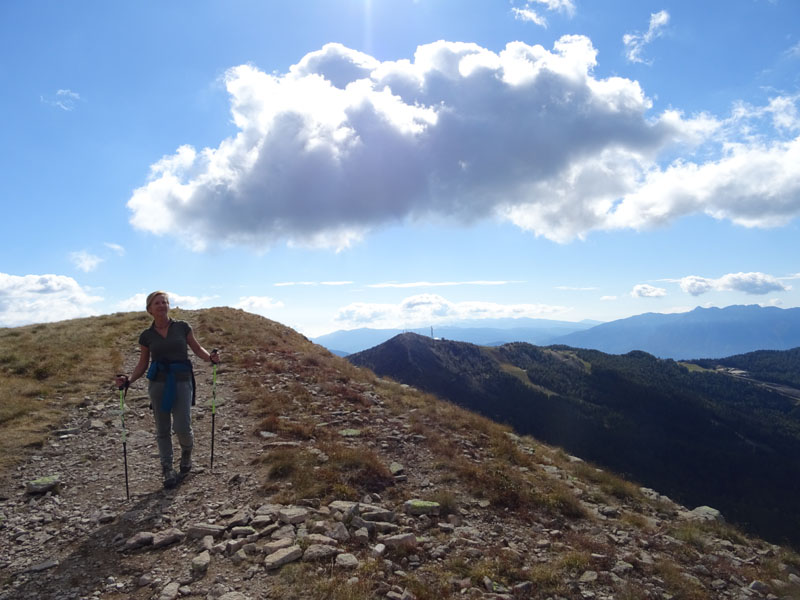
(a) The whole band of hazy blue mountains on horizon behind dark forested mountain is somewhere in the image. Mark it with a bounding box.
[313,305,800,359]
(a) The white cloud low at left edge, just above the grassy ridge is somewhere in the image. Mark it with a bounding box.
[0,273,102,327]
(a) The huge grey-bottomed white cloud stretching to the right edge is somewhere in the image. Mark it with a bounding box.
[128,38,800,250]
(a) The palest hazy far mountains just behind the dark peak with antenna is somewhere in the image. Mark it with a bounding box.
[312,318,599,356]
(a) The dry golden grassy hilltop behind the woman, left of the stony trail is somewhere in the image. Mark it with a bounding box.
[0,308,296,477]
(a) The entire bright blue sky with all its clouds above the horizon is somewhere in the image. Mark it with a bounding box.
[0,0,800,336]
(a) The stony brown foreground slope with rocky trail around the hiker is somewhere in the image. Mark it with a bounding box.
[0,338,800,600]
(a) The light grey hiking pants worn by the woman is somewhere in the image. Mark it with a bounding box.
[147,381,194,468]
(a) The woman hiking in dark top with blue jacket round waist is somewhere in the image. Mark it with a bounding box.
[116,290,219,489]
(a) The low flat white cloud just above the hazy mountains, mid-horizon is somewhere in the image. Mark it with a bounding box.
[336,294,569,328]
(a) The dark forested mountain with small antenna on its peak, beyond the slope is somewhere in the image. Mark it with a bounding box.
[348,332,800,546]
